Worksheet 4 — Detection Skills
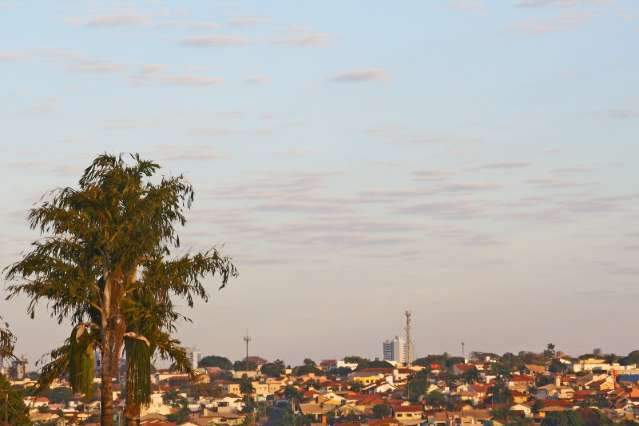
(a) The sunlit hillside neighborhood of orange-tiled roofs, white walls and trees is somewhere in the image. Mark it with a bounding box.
[2,344,639,426]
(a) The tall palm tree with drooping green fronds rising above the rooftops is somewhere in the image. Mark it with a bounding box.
[6,154,237,425]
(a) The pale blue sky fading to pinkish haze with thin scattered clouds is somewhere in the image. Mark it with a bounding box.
[0,0,639,364]
